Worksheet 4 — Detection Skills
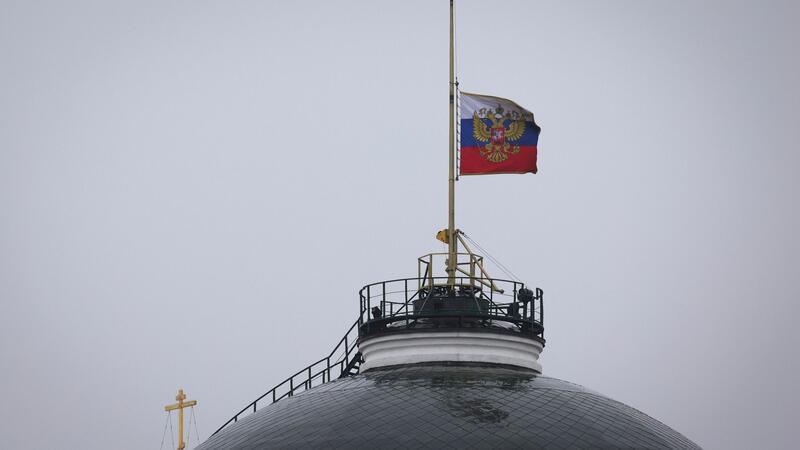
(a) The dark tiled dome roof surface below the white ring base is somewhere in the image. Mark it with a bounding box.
[198,362,699,450]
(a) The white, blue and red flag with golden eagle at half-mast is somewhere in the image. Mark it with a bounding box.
[460,92,542,175]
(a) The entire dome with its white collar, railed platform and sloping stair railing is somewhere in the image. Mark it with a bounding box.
[198,268,699,450]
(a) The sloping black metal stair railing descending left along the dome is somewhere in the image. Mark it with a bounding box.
[212,321,361,436]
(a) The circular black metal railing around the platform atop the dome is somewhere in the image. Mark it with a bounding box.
[358,276,544,342]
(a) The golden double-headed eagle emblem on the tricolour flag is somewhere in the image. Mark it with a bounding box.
[472,105,525,163]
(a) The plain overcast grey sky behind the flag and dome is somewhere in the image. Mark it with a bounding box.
[0,0,800,449]
